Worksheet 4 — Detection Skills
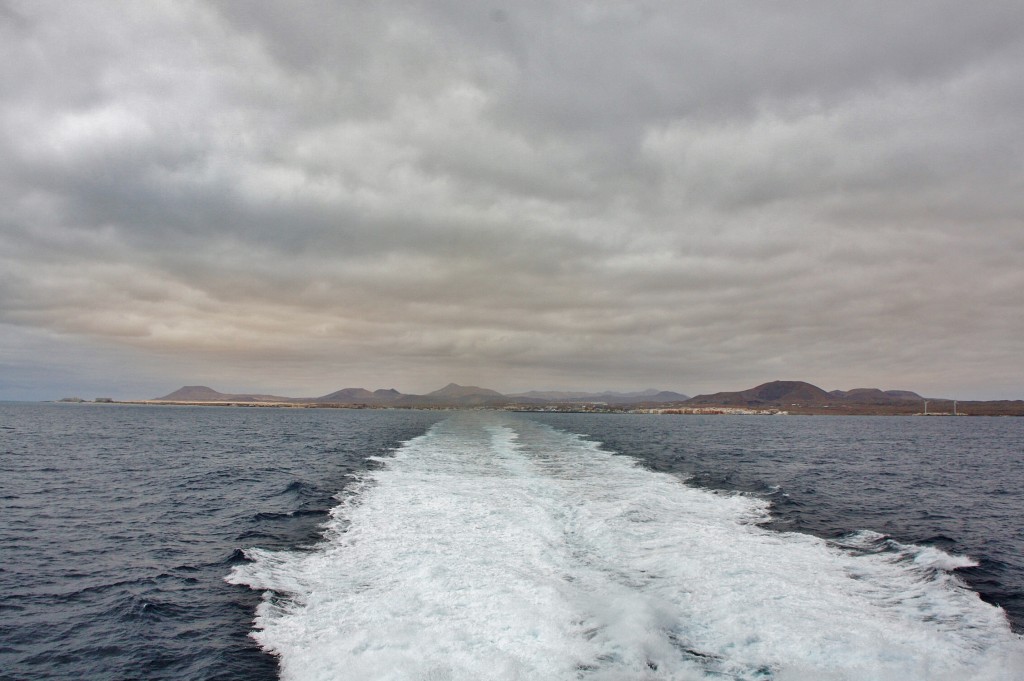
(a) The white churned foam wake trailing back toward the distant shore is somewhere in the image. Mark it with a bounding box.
[227,413,1024,681]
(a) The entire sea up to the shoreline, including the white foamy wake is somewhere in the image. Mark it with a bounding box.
[0,402,1024,681]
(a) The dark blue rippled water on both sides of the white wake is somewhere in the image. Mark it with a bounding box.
[0,405,1024,680]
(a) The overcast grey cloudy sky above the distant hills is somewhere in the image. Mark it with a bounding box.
[0,0,1024,399]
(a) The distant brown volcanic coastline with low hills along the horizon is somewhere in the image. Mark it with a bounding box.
[72,381,1024,416]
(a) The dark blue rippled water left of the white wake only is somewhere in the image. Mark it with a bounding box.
[0,405,446,679]
